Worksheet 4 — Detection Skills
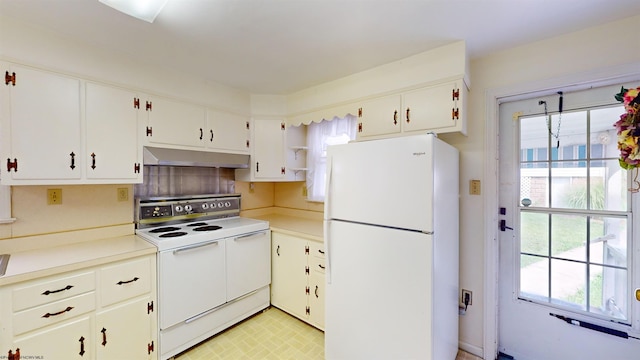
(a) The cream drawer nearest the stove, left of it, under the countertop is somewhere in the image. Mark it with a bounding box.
[100,257,151,306]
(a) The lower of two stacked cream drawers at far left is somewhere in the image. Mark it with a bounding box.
[13,291,96,335]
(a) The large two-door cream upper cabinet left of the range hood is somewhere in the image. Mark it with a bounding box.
[0,64,142,185]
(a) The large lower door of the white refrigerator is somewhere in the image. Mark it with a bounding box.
[325,221,436,360]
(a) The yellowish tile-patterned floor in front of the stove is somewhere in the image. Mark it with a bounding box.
[176,307,481,360]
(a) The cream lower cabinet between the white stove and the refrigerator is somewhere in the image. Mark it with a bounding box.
[271,231,325,330]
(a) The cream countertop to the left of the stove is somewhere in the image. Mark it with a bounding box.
[0,228,157,286]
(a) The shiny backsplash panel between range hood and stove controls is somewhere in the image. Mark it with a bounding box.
[134,165,235,197]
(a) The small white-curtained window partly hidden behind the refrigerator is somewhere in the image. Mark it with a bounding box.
[307,115,357,202]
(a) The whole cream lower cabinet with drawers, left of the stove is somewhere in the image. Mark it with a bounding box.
[0,254,157,360]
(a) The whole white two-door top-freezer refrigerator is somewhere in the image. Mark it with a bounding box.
[324,134,459,360]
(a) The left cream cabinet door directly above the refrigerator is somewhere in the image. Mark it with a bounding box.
[358,95,401,138]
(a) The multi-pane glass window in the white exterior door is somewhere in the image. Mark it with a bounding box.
[519,105,632,324]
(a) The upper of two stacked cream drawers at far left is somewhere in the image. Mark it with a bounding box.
[12,271,96,312]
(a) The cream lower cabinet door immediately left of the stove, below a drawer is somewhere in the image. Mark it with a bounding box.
[94,297,152,360]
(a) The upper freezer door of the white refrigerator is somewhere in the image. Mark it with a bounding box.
[325,135,444,231]
